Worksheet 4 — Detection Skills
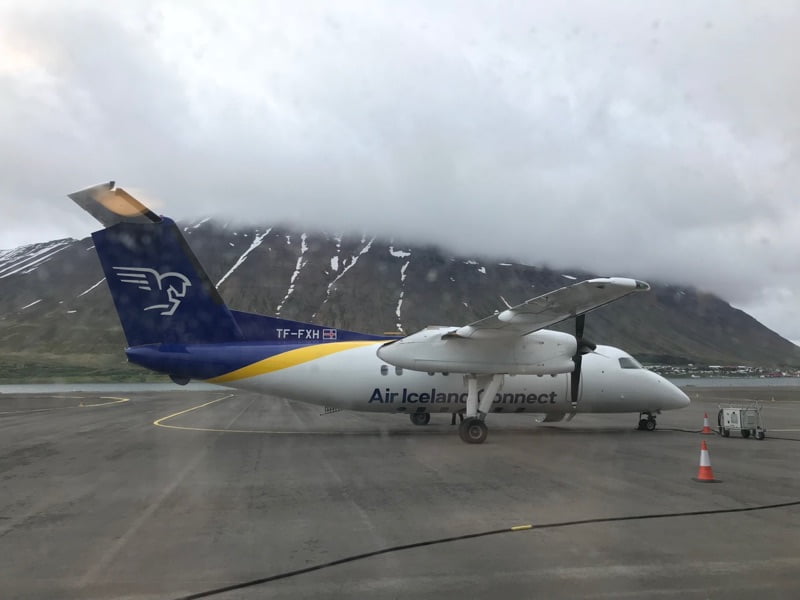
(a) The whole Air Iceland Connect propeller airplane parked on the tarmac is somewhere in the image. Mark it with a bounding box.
[69,181,689,444]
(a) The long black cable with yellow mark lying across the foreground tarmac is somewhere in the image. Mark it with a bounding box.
[175,500,800,600]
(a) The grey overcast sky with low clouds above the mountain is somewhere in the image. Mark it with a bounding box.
[0,0,800,341]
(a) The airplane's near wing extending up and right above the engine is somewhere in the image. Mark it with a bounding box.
[444,277,650,338]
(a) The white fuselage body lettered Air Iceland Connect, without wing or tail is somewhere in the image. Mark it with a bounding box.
[216,342,689,414]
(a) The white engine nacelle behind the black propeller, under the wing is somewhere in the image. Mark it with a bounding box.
[378,327,577,375]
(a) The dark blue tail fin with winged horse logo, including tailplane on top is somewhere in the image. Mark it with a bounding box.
[70,181,242,346]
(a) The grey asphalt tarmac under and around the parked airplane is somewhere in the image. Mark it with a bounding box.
[0,387,800,599]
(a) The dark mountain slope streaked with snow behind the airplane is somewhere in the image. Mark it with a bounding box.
[0,219,800,378]
